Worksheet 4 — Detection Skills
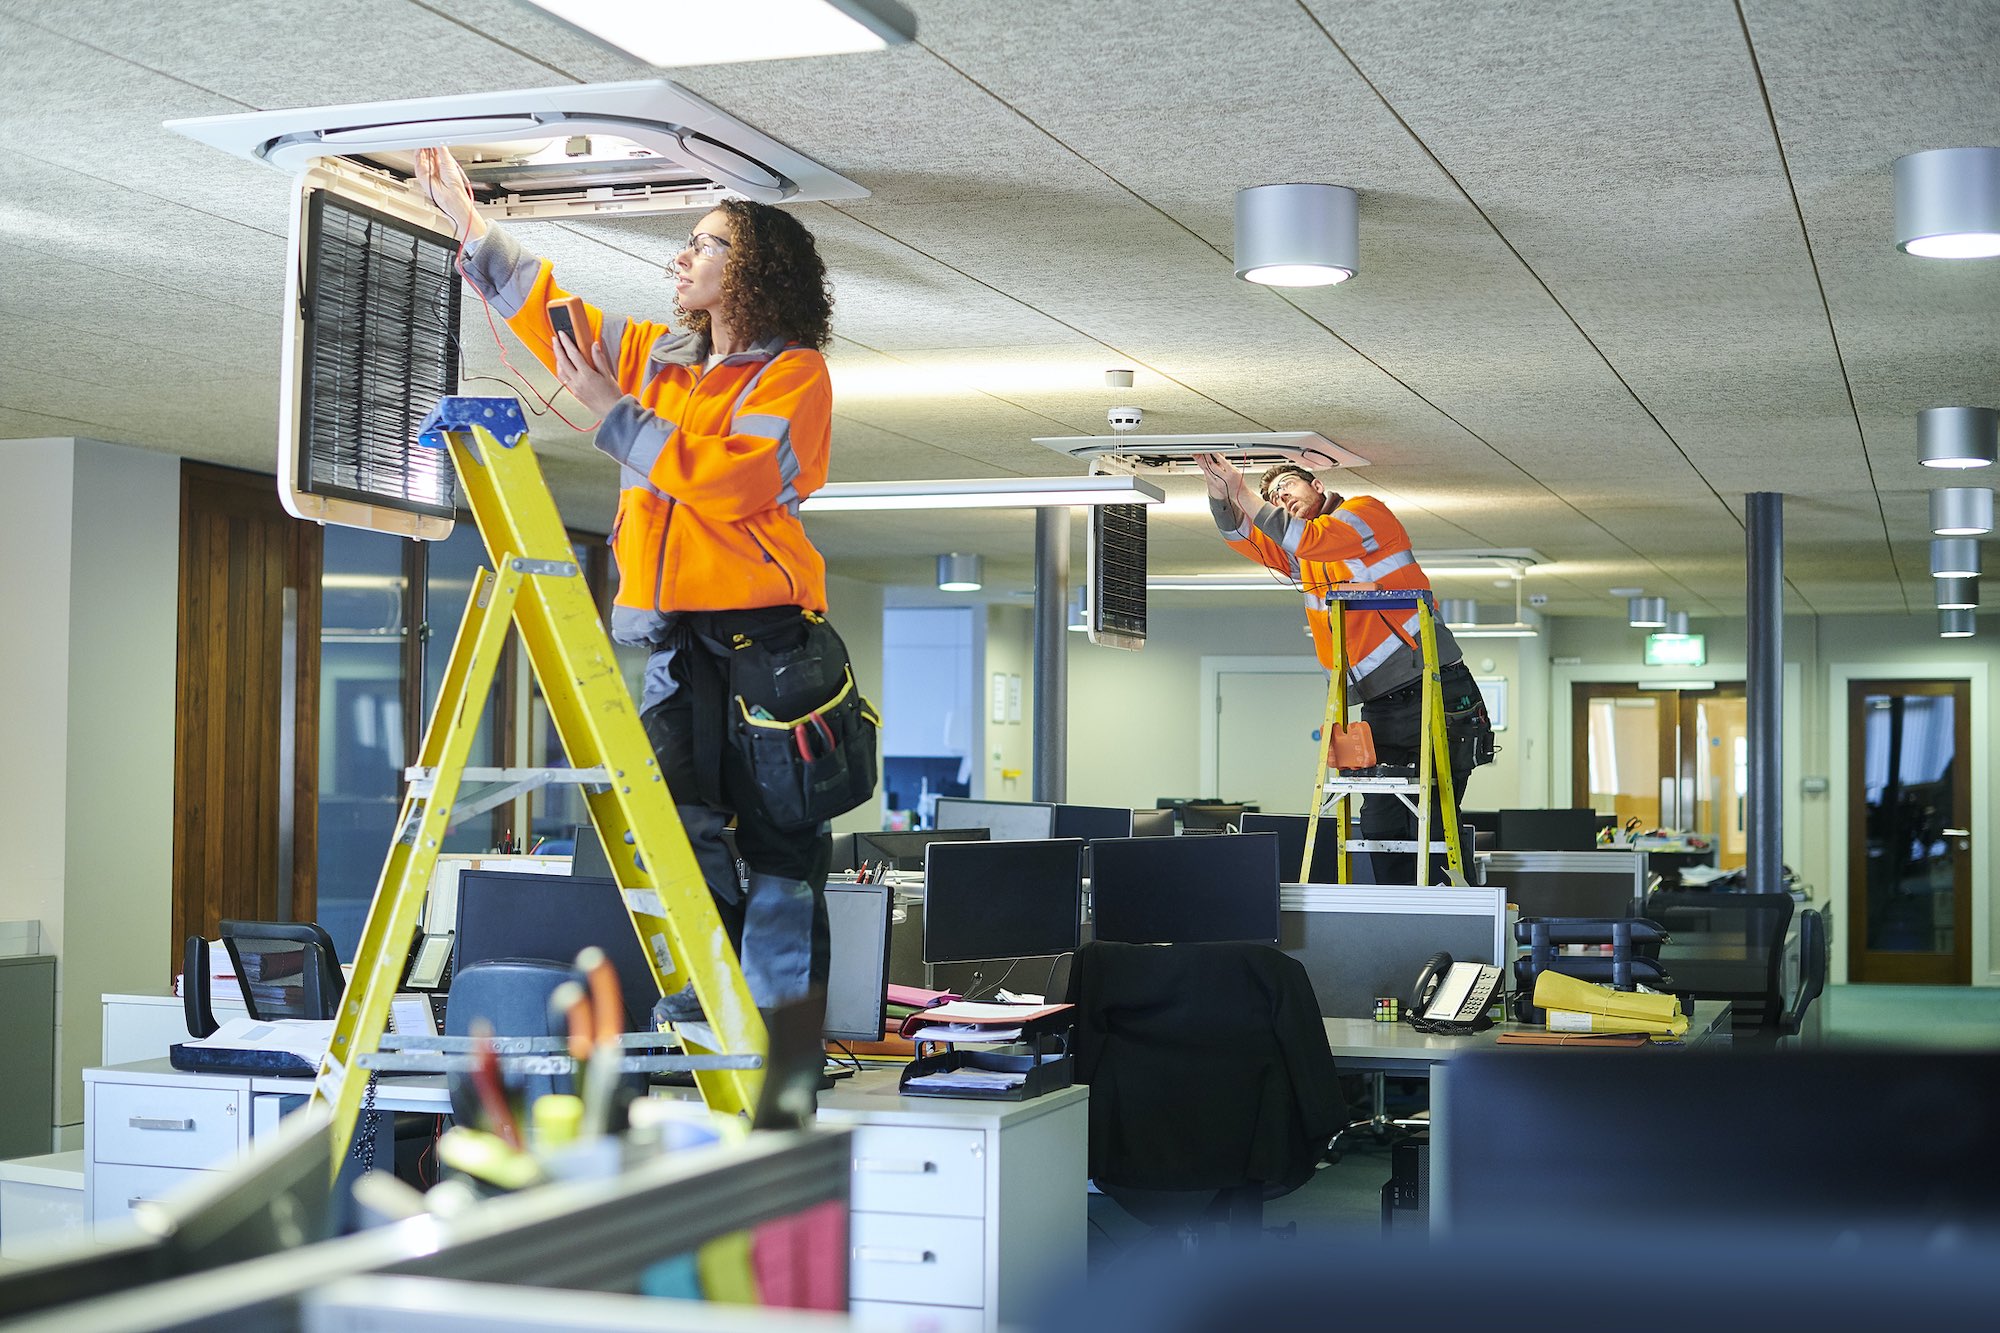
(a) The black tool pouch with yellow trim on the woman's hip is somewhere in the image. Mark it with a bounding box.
[724,612,882,829]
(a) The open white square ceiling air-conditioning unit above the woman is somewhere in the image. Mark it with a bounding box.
[166,78,868,218]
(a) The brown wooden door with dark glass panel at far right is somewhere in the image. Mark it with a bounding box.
[1846,681,1976,987]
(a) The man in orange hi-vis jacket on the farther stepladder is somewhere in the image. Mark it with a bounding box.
[1196,454,1492,885]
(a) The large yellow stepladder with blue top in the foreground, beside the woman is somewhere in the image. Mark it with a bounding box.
[312,396,766,1173]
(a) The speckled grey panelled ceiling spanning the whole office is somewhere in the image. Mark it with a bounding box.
[0,0,2000,618]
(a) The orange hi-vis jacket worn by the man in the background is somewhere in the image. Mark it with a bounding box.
[1210,494,1460,703]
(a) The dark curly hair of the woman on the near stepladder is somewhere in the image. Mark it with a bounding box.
[676,198,834,348]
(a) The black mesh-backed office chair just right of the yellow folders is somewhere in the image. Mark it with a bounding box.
[1644,889,1794,1035]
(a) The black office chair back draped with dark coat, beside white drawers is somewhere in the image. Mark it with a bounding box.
[1068,941,1346,1241]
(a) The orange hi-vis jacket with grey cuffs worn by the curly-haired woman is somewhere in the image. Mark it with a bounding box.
[466,226,834,644]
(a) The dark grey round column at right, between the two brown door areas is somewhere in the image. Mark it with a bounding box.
[1744,490,1784,893]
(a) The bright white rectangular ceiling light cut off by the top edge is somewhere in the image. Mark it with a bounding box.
[528,0,916,66]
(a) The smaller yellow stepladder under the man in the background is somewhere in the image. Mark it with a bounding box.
[1298,584,1466,885]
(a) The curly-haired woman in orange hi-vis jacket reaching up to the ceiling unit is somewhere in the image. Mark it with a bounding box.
[418,148,874,1047]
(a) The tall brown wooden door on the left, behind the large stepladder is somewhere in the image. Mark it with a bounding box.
[168,462,320,971]
